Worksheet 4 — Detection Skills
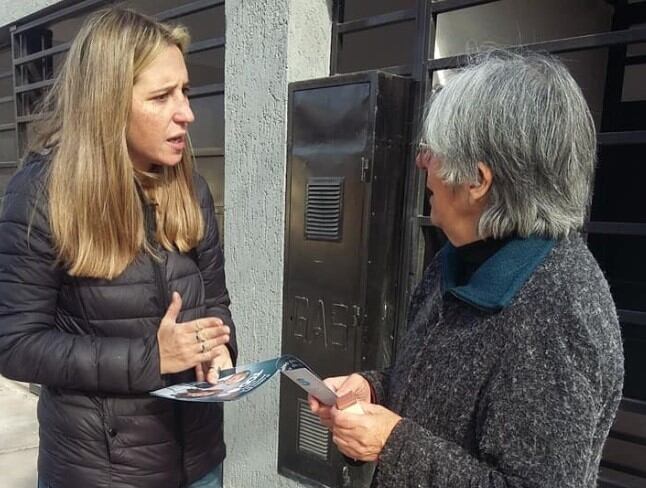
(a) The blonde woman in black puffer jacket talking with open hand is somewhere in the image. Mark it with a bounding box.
[0,10,237,488]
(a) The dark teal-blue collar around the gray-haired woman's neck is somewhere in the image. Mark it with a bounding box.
[440,237,556,312]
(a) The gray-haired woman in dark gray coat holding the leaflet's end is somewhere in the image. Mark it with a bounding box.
[310,53,623,488]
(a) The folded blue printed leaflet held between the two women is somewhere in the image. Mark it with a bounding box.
[150,355,337,405]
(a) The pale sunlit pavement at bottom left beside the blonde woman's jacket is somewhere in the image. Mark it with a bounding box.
[0,376,38,488]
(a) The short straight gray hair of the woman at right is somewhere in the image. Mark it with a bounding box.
[420,51,596,238]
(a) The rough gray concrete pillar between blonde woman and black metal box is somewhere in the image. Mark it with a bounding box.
[224,0,331,488]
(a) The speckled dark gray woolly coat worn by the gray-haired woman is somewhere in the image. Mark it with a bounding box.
[364,236,623,488]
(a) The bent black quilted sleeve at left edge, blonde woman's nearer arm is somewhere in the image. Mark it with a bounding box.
[0,163,162,394]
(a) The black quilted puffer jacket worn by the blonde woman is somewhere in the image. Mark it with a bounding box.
[0,157,237,488]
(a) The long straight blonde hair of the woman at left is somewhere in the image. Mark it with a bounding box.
[31,9,204,279]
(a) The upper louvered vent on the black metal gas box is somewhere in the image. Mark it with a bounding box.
[305,177,343,241]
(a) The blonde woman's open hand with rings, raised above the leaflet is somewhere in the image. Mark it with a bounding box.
[157,292,230,374]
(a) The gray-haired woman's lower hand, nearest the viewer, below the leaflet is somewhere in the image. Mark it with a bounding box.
[331,402,401,461]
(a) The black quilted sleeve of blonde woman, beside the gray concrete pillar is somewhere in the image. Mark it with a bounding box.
[196,175,238,365]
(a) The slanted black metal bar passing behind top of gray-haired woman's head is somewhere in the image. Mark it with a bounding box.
[427,27,646,71]
